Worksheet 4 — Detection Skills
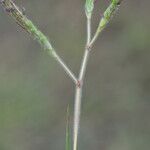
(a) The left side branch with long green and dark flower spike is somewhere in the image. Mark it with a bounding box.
[0,0,78,84]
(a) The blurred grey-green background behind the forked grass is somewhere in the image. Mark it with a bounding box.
[0,0,150,150]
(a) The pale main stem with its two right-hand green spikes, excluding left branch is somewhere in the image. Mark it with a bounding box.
[73,0,122,150]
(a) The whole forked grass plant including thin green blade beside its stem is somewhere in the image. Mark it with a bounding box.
[0,0,122,150]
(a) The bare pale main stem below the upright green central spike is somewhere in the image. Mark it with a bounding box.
[73,17,91,150]
